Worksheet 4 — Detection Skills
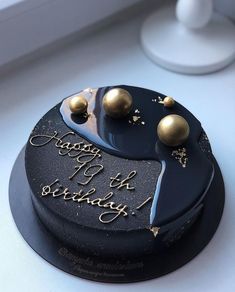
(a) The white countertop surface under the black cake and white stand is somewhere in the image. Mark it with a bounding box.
[0,2,235,292]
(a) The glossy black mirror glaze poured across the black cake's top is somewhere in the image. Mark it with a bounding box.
[60,85,214,227]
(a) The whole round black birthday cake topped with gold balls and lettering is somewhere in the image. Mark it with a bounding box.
[21,86,224,282]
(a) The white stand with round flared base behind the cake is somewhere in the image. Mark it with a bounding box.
[141,0,235,74]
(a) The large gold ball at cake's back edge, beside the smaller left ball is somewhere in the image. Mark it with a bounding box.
[103,88,132,118]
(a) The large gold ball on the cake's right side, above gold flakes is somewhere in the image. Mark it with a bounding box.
[157,115,190,147]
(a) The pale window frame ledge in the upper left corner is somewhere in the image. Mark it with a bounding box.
[0,0,139,66]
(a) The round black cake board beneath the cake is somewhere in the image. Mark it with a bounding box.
[9,148,224,283]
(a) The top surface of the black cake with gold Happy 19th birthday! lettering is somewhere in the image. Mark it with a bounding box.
[26,86,213,231]
